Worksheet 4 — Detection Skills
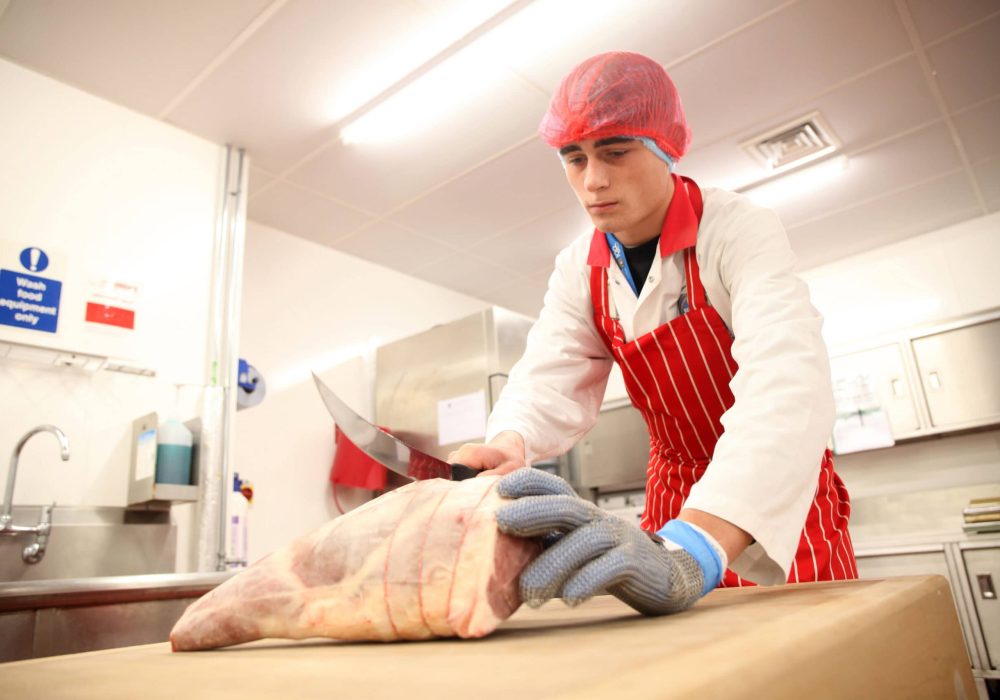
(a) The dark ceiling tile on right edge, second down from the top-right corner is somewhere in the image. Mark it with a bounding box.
[927,14,1000,112]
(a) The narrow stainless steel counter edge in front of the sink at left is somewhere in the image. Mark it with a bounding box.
[0,571,238,612]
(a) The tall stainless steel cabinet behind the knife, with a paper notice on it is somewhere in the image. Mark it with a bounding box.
[375,307,534,459]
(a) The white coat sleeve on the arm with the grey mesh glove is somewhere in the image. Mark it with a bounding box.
[685,200,835,584]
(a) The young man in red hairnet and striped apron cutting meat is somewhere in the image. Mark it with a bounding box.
[451,52,857,614]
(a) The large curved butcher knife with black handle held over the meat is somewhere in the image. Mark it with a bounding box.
[313,372,479,481]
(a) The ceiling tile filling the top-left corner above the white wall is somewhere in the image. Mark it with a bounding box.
[0,0,272,116]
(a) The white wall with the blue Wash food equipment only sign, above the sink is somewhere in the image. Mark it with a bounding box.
[0,60,223,506]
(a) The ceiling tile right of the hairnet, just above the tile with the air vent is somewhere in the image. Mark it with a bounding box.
[671,0,912,148]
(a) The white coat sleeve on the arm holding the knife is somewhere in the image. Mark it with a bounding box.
[486,240,613,464]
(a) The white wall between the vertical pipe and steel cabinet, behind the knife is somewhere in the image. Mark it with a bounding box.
[232,222,487,560]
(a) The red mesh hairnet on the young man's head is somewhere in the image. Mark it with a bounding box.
[538,51,691,158]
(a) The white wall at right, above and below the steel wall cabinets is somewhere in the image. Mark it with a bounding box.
[802,214,1000,546]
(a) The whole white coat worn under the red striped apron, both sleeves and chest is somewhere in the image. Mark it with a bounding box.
[487,183,835,584]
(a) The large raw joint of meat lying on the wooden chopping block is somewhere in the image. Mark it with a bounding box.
[170,476,540,651]
